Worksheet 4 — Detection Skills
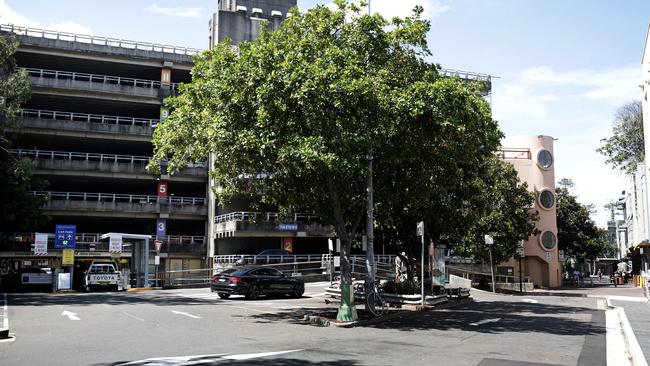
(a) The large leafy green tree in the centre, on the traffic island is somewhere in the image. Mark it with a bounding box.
[150,0,502,315]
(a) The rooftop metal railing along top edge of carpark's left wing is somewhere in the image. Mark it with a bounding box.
[0,24,203,56]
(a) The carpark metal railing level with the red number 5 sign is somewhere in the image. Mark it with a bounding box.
[32,191,206,206]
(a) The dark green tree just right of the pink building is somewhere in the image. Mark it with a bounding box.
[555,178,616,259]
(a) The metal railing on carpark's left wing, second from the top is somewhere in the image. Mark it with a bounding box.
[25,68,178,90]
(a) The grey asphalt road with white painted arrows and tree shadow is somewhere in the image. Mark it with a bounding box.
[0,285,606,366]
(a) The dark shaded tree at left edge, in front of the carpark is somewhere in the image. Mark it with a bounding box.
[0,36,43,232]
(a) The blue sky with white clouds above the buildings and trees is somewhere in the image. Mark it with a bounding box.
[0,0,650,226]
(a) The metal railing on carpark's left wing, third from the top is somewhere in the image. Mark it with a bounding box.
[20,109,160,127]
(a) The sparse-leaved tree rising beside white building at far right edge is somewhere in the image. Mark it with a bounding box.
[596,100,645,173]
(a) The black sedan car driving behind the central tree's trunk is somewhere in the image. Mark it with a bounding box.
[210,266,305,300]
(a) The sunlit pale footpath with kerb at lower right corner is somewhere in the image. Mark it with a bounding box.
[535,283,650,366]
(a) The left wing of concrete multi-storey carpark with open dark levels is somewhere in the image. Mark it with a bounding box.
[0,26,207,288]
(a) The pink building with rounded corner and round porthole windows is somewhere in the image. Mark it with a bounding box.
[502,135,562,288]
